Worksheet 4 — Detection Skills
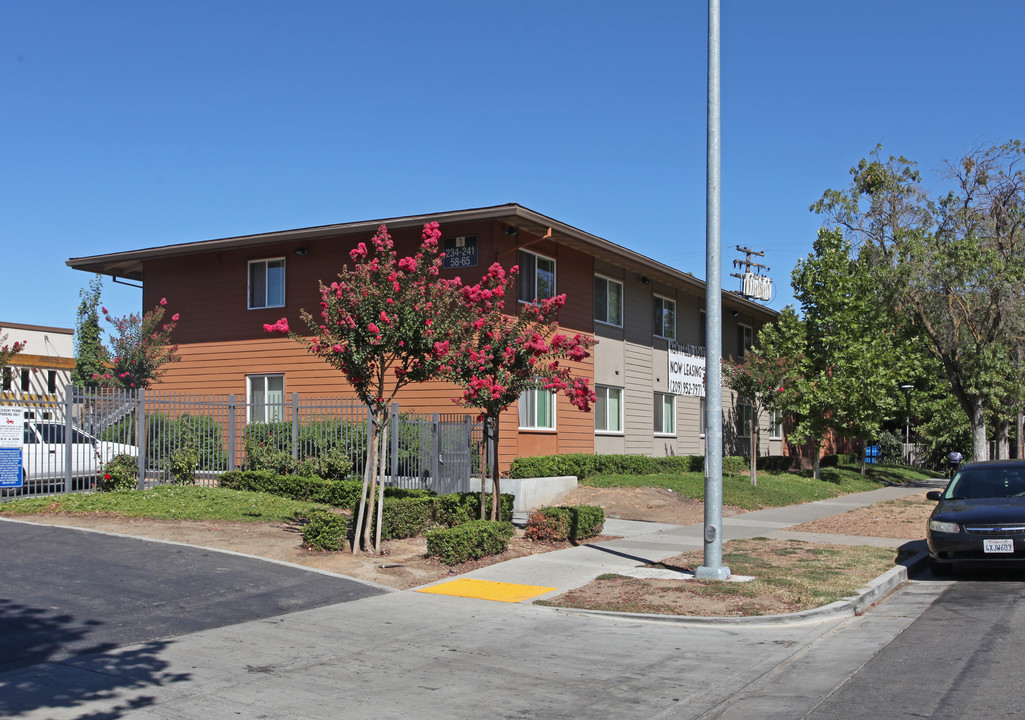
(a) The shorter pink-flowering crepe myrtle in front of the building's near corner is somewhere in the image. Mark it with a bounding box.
[444,263,596,520]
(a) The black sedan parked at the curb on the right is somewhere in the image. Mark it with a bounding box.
[926,461,1025,575]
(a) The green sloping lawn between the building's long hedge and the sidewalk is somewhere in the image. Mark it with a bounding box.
[580,466,932,510]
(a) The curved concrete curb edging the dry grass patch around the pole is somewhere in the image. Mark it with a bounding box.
[536,552,929,626]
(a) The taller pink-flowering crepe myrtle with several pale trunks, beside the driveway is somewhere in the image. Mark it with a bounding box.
[263,223,466,553]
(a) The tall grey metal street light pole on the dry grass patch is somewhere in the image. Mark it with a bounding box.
[694,0,730,579]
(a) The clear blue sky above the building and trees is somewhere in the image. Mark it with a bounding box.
[0,0,1025,332]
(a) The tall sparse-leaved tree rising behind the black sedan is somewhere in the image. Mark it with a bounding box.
[812,141,1025,459]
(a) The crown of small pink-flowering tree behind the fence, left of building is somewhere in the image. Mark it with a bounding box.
[93,297,180,389]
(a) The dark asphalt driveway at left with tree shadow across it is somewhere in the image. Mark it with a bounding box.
[0,521,385,672]
